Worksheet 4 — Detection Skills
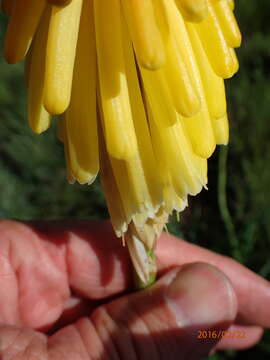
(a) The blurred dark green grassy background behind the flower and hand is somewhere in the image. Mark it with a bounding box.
[0,0,270,360]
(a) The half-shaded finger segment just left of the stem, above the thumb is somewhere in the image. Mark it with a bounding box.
[62,227,130,299]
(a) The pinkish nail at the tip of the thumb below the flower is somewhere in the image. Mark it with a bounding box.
[165,263,236,328]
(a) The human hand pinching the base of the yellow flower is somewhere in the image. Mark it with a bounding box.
[0,220,270,360]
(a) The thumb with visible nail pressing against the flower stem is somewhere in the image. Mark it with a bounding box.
[66,263,237,360]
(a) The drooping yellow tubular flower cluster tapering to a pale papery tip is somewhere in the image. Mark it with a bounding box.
[2,0,241,284]
